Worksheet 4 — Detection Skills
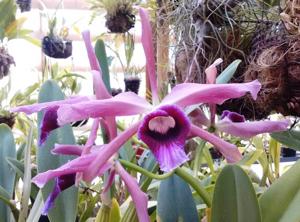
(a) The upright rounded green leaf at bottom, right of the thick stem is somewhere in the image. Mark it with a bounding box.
[211,165,260,222]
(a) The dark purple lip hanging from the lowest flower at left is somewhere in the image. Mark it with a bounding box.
[42,174,75,215]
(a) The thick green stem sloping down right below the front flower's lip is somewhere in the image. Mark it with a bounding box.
[175,168,212,207]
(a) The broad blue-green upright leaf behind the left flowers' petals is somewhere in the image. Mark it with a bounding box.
[37,80,78,222]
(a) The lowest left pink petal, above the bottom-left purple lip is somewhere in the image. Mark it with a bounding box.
[32,153,97,187]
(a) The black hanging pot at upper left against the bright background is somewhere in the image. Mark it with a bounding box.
[42,36,72,59]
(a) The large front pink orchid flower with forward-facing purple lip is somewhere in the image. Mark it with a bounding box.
[14,9,261,174]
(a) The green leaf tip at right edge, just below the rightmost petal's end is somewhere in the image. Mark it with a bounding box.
[271,130,300,151]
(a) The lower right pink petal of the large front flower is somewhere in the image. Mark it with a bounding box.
[191,125,242,163]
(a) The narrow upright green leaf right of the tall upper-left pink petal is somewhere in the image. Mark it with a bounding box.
[95,39,111,92]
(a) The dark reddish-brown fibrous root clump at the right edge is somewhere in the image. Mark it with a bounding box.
[221,38,300,119]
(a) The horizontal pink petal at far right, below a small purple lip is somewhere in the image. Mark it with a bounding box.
[216,117,289,138]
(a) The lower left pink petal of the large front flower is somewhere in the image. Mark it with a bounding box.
[83,122,140,181]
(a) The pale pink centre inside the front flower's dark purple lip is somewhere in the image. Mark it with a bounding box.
[148,116,176,134]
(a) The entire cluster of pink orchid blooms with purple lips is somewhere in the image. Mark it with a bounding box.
[12,8,288,222]
